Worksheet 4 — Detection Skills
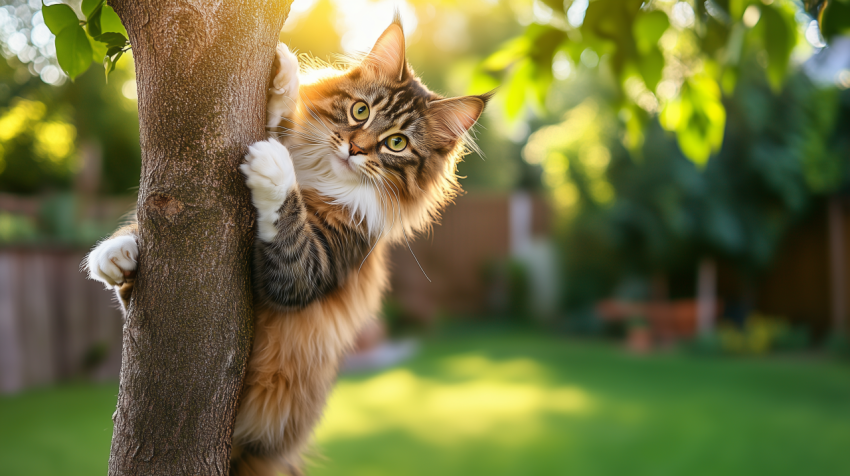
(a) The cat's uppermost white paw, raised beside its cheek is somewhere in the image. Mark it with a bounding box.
[266,43,298,133]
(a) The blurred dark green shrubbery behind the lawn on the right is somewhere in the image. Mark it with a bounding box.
[544,65,850,308]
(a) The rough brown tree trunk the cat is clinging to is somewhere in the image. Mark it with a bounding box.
[109,0,291,475]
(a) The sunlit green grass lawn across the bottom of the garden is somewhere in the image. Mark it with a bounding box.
[0,331,850,476]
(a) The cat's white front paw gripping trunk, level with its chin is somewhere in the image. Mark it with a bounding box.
[239,139,295,241]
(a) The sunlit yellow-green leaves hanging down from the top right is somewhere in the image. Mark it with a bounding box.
[477,0,832,166]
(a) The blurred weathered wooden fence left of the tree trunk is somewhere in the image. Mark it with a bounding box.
[0,248,122,393]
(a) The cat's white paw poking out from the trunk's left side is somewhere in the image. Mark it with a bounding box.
[83,223,139,316]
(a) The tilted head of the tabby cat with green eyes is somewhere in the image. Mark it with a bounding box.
[292,18,491,237]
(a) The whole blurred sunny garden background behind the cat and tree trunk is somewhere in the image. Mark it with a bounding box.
[0,0,850,475]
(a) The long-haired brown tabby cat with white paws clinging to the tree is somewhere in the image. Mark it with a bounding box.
[88,18,490,475]
